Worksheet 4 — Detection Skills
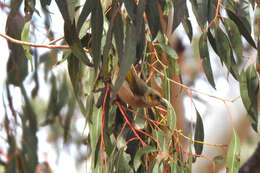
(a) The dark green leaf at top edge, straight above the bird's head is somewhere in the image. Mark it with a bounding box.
[145,1,162,40]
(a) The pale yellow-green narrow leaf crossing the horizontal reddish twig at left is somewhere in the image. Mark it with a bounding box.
[21,21,33,69]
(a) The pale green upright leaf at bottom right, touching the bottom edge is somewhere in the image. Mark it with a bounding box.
[226,128,240,172]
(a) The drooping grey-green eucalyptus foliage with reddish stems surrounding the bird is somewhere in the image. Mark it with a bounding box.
[1,0,260,173]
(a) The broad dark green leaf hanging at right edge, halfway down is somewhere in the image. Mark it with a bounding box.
[239,65,259,131]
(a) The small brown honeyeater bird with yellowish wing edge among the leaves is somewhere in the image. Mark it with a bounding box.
[115,66,163,108]
